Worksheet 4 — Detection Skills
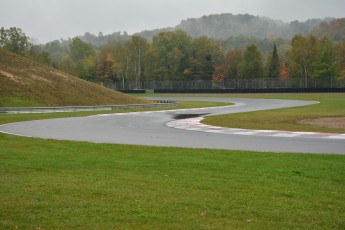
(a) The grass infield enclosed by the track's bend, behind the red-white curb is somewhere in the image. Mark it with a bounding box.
[196,93,345,133]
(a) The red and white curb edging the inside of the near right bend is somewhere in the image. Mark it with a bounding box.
[165,117,345,140]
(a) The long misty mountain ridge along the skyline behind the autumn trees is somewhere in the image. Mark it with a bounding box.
[47,13,338,50]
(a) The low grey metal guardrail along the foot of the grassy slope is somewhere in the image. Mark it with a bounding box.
[0,101,180,114]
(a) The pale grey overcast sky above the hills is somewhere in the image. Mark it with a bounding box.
[0,0,345,43]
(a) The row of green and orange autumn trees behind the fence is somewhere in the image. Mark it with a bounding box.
[0,28,345,88]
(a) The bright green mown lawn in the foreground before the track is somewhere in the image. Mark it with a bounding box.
[0,95,345,229]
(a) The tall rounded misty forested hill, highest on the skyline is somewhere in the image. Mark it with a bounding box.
[137,14,332,39]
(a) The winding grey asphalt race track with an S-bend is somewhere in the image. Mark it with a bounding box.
[0,97,345,154]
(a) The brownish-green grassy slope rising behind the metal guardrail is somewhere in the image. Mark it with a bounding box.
[0,49,148,107]
